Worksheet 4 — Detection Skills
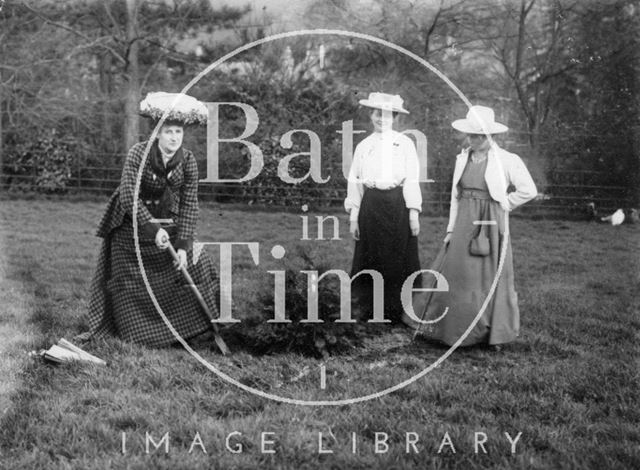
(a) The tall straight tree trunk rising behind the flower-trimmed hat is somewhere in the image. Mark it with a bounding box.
[124,0,140,152]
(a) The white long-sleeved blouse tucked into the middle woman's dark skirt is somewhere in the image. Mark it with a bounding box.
[344,131,422,221]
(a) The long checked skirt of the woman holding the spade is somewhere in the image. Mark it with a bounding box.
[89,222,218,347]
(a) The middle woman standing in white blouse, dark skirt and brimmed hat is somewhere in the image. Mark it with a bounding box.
[344,93,422,321]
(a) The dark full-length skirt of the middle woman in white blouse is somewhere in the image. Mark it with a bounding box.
[351,187,420,321]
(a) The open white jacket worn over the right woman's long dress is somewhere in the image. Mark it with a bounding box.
[447,144,538,232]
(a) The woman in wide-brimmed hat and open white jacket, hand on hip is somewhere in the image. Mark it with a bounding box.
[414,106,537,349]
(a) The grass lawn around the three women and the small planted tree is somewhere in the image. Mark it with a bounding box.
[0,199,640,469]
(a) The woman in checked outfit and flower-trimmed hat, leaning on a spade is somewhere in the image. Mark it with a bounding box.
[89,93,218,347]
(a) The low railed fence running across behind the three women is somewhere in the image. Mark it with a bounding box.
[0,161,631,214]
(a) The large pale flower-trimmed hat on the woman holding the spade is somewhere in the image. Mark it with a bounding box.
[140,91,209,126]
